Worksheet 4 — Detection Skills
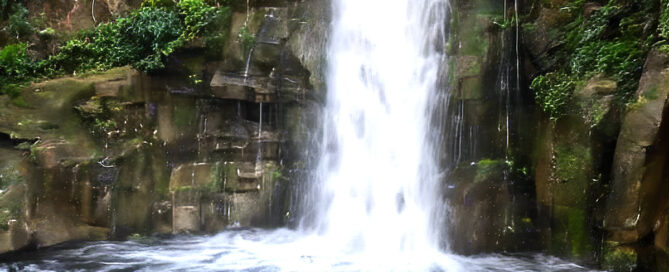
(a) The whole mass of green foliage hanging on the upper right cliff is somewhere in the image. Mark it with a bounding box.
[531,0,648,120]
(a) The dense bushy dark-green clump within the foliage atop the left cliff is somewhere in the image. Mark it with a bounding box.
[43,7,183,76]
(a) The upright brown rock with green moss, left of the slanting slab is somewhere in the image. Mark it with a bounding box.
[534,116,602,261]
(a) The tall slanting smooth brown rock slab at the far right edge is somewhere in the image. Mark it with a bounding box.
[604,51,669,243]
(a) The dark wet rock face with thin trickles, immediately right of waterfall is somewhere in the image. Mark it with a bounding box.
[440,1,540,254]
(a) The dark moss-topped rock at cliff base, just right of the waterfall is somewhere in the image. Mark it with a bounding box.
[448,159,537,254]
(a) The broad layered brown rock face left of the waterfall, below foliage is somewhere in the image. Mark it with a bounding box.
[0,1,328,253]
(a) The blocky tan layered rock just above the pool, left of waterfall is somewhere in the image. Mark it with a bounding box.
[170,162,277,232]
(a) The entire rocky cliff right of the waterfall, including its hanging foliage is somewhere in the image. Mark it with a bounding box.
[446,0,669,271]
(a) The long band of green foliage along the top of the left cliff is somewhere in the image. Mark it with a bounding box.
[0,0,230,102]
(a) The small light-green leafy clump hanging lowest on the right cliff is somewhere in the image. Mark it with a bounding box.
[530,72,575,120]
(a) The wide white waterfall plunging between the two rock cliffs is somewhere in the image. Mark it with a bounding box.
[303,0,456,270]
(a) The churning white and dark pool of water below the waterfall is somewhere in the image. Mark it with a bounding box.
[0,229,595,272]
